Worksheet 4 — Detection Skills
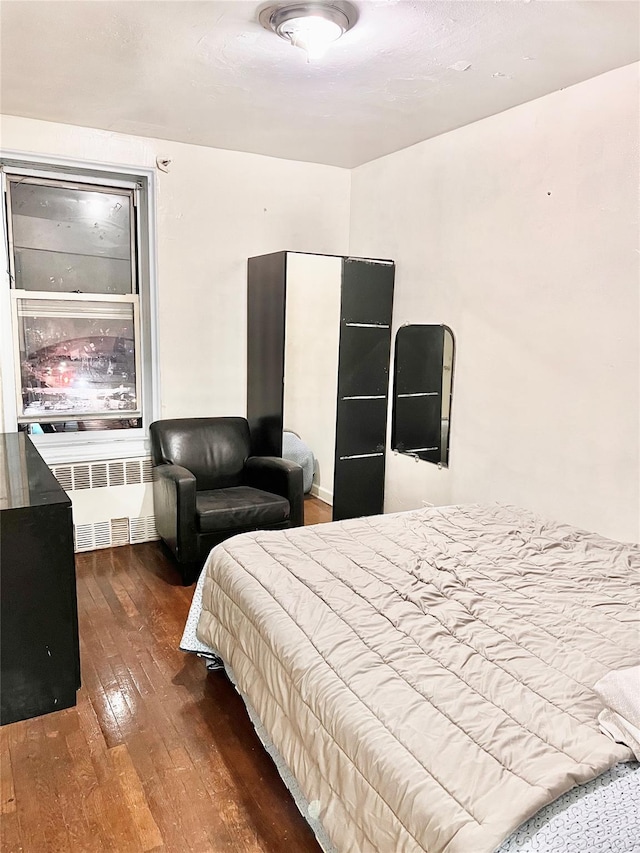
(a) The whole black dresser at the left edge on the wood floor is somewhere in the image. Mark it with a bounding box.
[0,433,80,725]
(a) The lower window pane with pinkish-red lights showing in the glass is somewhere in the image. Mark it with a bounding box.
[18,299,138,421]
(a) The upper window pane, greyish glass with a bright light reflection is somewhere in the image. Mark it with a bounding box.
[10,181,133,293]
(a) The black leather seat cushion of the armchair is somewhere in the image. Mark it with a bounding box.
[196,486,290,533]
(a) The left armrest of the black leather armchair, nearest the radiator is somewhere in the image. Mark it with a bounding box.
[153,465,198,563]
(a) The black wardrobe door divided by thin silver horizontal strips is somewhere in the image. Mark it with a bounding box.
[333,258,395,521]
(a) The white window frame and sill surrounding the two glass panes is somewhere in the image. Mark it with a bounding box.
[0,151,160,464]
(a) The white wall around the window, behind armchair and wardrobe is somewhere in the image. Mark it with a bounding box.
[0,116,350,417]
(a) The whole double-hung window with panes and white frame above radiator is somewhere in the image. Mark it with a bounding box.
[2,164,153,455]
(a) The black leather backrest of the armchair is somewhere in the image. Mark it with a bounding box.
[149,418,251,490]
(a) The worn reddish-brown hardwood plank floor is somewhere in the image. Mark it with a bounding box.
[0,498,331,853]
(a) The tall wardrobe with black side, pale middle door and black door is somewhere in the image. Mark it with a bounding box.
[247,252,395,520]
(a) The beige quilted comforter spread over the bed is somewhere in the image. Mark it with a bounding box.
[198,506,640,853]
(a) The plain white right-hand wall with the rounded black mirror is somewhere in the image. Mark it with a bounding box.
[350,66,640,540]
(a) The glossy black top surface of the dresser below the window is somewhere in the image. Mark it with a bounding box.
[0,432,71,510]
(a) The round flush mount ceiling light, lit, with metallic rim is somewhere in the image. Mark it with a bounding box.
[260,2,357,62]
